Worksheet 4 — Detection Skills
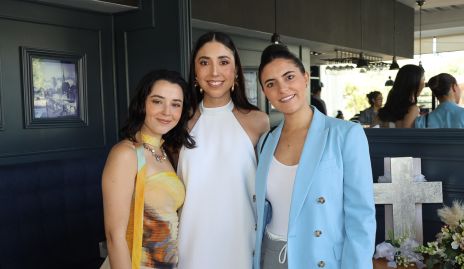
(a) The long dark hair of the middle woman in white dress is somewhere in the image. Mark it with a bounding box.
[189,32,258,113]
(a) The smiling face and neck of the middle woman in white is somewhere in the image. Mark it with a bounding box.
[195,41,236,107]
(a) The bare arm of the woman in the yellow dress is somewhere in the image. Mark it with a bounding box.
[102,141,137,269]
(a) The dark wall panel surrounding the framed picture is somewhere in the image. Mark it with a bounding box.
[0,0,117,164]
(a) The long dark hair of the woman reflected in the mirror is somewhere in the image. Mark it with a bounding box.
[377,64,424,122]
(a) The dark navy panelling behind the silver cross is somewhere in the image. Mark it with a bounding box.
[365,129,464,242]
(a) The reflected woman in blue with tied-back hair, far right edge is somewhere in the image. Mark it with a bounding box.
[415,73,464,128]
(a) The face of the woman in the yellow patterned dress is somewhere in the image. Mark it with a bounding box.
[141,80,184,137]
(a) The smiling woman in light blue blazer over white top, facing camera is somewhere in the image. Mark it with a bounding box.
[254,44,376,269]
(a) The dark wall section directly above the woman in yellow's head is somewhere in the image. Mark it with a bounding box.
[115,0,190,126]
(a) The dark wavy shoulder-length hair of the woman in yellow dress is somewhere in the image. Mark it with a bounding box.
[120,70,195,152]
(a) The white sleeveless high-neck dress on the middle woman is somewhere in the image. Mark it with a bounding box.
[177,101,256,269]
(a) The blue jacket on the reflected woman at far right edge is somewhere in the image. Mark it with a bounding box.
[414,102,464,128]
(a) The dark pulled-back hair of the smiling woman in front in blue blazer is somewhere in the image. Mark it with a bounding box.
[258,44,306,87]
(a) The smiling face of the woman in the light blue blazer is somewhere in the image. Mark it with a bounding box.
[260,58,309,114]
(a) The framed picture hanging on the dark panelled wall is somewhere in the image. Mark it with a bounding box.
[21,47,88,128]
